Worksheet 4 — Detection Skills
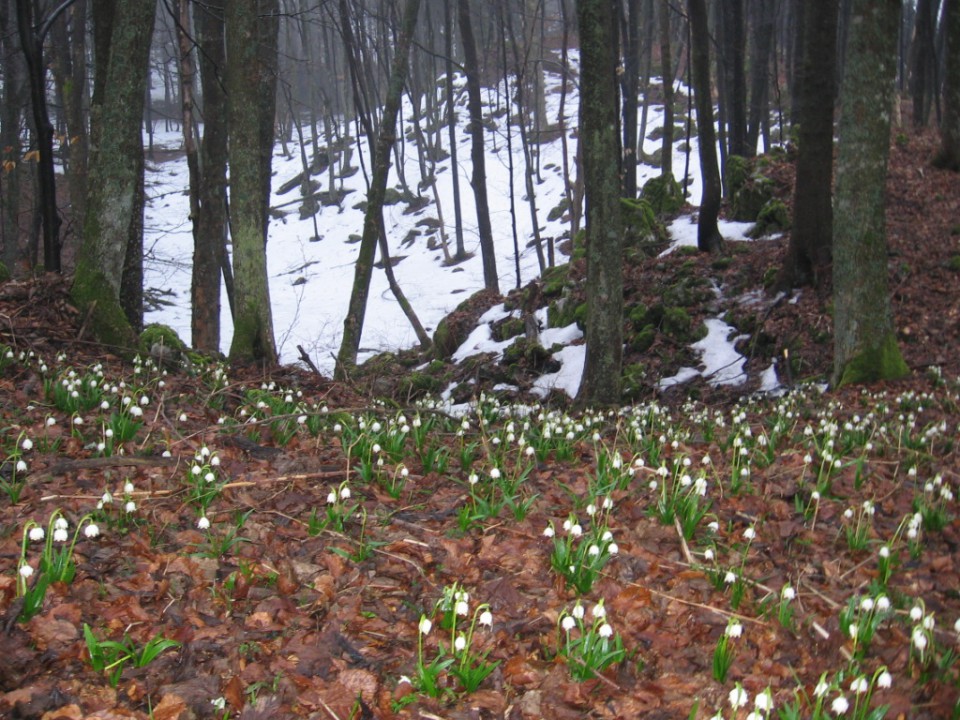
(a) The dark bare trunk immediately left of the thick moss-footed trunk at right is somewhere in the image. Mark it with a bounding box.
[777,0,839,289]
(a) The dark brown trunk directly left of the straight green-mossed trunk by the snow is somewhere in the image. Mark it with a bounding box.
[192,0,232,353]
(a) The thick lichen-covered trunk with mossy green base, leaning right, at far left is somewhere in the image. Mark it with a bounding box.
[72,0,156,347]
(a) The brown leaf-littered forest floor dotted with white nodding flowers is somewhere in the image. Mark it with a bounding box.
[0,135,960,720]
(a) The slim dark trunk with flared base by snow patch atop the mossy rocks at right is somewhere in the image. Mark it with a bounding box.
[687,0,723,252]
